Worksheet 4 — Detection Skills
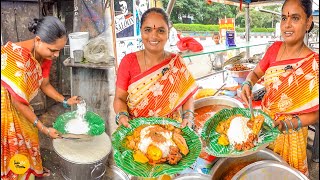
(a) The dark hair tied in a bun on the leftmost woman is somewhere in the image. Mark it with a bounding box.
[28,16,67,44]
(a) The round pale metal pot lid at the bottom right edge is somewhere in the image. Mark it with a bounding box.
[232,160,308,180]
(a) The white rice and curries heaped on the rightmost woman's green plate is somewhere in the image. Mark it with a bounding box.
[216,115,264,151]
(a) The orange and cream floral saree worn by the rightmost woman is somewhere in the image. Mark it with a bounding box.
[262,53,319,176]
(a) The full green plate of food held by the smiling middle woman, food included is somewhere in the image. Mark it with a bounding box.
[112,117,201,178]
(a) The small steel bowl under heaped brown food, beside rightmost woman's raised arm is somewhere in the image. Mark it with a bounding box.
[223,63,256,84]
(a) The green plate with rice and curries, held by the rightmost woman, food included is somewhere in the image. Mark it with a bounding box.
[201,107,280,157]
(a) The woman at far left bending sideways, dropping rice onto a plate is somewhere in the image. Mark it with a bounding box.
[1,16,78,180]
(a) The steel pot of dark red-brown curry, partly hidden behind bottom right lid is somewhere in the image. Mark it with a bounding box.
[210,149,287,179]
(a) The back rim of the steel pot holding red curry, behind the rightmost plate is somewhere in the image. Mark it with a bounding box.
[194,96,244,109]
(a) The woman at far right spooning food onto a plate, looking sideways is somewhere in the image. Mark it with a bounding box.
[242,0,319,176]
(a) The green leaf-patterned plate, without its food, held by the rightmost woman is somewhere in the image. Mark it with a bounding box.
[201,107,280,157]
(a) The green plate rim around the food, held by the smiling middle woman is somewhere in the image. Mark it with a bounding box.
[112,117,202,177]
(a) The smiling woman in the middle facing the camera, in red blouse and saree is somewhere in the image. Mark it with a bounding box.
[114,8,197,127]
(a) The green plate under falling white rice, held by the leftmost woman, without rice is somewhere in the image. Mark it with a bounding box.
[53,111,105,136]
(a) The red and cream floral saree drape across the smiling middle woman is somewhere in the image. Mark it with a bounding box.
[127,55,198,122]
